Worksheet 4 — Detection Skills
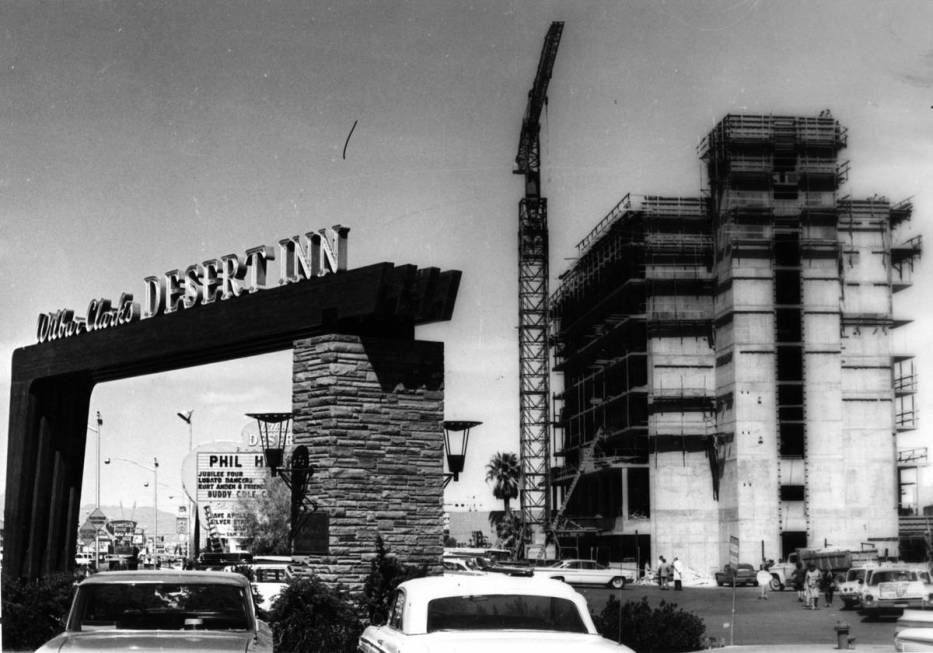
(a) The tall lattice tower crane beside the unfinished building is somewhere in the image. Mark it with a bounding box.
[514,22,564,545]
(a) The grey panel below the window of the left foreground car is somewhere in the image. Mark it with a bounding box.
[41,630,255,653]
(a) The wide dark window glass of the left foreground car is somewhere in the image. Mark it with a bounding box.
[68,583,250,630]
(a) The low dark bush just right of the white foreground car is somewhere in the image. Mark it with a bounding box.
[593,595,706,653]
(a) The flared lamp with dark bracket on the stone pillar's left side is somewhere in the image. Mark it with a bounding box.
[246,413,318,550]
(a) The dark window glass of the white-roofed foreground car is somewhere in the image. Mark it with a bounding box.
[427,594,587,633]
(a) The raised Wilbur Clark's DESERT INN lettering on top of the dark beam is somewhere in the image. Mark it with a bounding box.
[36,225,350,343]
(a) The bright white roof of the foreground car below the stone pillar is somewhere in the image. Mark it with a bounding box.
[399,574,578,600]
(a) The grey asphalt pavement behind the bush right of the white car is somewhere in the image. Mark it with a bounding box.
[576,584,895,651]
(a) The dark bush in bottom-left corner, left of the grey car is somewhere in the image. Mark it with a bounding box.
[2,573,74,651]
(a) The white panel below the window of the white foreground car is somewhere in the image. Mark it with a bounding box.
[403,630,634,653]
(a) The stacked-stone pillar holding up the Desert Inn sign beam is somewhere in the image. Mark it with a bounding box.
[292,334,444,591]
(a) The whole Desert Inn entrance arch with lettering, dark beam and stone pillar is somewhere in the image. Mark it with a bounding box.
[3,225,461,587]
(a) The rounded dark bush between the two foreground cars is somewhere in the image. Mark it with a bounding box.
[269,576,363,653]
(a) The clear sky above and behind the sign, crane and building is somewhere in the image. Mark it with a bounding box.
[0,0,933,510]
